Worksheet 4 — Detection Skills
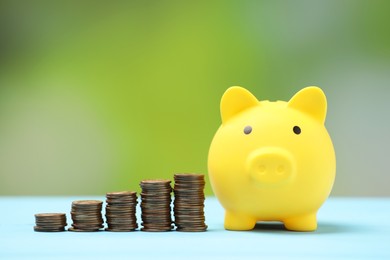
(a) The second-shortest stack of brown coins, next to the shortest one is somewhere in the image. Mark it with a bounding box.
[68,200,103,232]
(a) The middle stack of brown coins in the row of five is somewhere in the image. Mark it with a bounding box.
[106,191,138,232]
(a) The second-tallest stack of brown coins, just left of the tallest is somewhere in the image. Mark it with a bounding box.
[140,180,172,232]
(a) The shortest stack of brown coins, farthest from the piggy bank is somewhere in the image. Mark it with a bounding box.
[34,213,67,232]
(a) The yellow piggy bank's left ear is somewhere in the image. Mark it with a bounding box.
[220,87,259,124]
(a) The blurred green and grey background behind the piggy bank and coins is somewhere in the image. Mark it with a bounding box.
[0,0,390,196]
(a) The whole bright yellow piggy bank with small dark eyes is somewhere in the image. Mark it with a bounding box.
[208,87,336,231]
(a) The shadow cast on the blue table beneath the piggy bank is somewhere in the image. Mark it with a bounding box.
[252,222,356,235]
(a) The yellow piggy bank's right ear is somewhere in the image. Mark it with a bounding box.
[288,87,327,123]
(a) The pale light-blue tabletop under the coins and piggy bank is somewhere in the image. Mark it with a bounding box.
[0,196,390,259]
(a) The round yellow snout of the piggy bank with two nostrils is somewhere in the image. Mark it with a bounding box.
[247,147,296,184]
